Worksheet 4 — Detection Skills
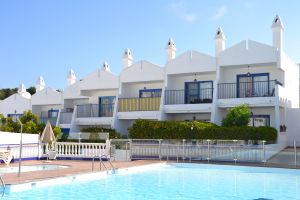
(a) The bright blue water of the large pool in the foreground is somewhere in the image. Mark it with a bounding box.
[3,164,300,200]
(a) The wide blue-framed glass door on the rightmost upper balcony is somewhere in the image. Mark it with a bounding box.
[236,73,270,98]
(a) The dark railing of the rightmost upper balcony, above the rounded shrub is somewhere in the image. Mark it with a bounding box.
[218,80,280,99]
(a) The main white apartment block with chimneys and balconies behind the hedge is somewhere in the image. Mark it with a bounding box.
[0,16,299,143]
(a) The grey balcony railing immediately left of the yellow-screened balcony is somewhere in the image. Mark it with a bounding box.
[77,104,114,118]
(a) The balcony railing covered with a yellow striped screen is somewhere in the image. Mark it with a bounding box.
[118,97,160,112]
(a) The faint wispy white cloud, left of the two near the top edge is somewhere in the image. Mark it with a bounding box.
[168,1,198,23]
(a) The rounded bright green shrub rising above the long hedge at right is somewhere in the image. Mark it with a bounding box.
[222,105,250,127]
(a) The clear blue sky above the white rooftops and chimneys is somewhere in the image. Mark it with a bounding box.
[0,0,300,89]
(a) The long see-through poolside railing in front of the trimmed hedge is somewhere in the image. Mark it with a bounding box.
[111,140,266,162]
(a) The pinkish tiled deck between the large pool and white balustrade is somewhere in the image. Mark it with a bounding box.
[0,160,159,184]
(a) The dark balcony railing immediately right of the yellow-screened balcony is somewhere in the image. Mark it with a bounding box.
[165,88,213,105]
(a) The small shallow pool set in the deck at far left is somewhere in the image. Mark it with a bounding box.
[0,165,68,174]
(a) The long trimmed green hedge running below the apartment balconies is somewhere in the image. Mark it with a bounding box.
[128,119,277,142]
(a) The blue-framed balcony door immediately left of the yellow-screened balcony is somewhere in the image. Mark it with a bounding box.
[99,96,116,117]
